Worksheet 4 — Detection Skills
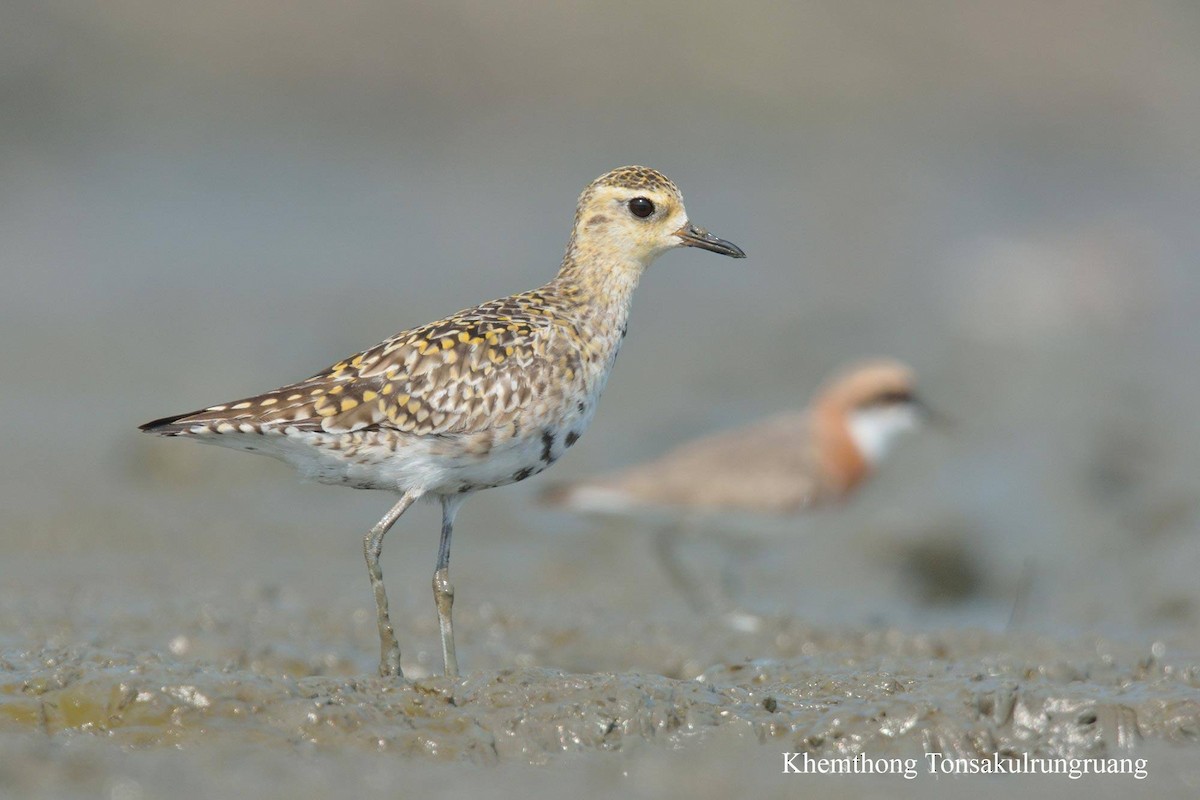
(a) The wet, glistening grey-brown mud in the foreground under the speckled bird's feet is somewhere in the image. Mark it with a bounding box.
[0,602,1200,796]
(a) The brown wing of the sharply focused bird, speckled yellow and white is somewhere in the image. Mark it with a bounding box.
[143,295,577,435]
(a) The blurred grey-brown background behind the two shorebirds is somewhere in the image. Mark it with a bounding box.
[0,0,1200,672]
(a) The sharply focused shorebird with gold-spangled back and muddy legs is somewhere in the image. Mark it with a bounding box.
[140,167,745,676]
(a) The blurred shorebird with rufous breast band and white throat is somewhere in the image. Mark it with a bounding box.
[541,359,932,608]
